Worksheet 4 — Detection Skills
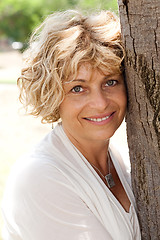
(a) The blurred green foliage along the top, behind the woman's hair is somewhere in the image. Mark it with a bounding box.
[0,0,117,46]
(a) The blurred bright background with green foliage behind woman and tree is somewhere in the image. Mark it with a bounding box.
[0,0,127,240]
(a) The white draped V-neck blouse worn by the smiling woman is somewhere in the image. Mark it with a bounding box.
[2,124,141,240]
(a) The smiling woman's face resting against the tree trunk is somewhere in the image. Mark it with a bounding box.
[60,64,127,143]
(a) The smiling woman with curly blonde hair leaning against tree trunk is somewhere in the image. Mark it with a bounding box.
[3,10,141,240]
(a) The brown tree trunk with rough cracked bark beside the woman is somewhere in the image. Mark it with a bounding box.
[118,0,160,240]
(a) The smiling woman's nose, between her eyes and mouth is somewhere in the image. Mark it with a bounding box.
[89,90,109,110]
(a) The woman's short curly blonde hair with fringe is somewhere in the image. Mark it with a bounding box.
[17,10,124,123]
